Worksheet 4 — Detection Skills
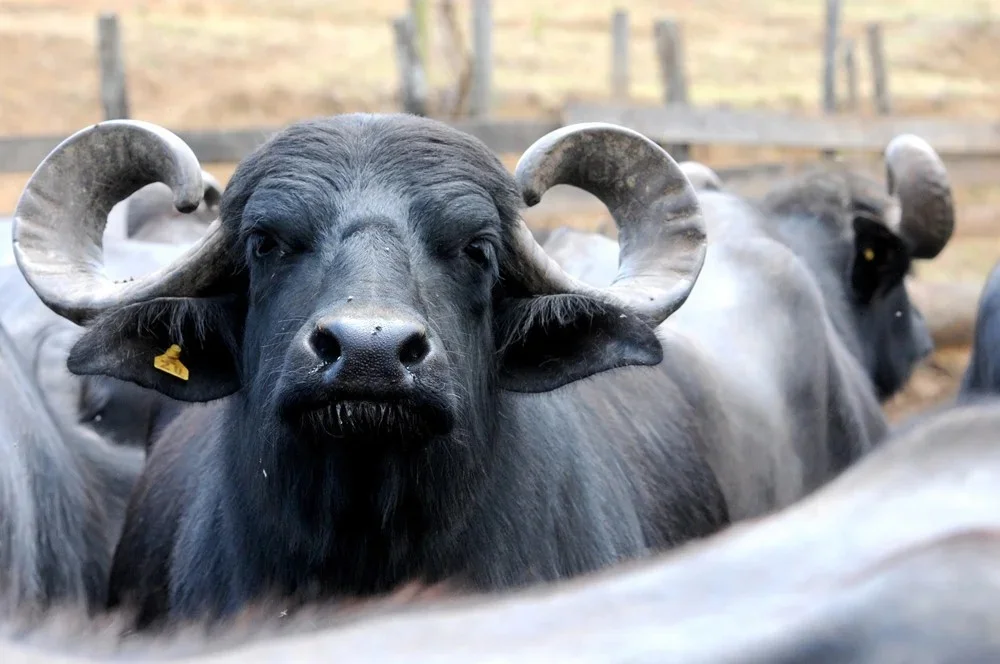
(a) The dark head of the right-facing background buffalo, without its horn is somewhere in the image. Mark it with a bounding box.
[760,165,934,401]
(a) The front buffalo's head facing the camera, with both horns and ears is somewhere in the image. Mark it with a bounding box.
[14,115,705,452]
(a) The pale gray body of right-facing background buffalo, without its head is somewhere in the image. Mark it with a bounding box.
[544,190,887,520]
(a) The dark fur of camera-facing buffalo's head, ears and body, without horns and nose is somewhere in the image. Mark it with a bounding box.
[69,116,731,622]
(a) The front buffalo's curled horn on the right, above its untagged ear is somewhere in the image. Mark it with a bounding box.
[515,123,706,325]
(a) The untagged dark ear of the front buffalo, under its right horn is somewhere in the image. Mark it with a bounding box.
[494,295,663,392]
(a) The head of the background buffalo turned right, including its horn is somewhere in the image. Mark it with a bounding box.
[761,135,955,400]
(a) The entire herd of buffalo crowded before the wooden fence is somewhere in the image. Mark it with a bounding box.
[0,114,1000,664]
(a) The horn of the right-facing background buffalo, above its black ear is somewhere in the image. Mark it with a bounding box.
[884,134,955,258]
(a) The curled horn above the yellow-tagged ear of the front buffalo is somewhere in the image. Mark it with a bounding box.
[12,120,226,325]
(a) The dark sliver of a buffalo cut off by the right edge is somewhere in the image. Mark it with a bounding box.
[958,263,1000,401]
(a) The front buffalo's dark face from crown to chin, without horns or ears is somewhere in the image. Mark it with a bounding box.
[224,123,518,445]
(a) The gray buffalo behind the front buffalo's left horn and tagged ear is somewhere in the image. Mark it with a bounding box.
[0,172,221,448]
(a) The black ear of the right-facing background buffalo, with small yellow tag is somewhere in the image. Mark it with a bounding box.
[851,217,910,304]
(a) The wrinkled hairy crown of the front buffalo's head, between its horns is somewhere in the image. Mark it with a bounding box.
[221,113,521,236]
